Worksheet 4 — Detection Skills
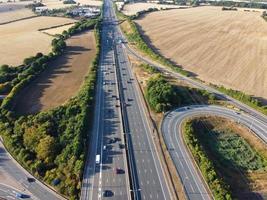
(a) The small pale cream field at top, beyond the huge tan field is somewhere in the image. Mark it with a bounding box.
[122,2,187,16]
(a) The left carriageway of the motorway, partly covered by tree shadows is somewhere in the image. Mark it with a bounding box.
[81,1,130,200]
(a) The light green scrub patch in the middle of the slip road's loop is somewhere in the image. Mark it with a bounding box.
[199,127,267,171]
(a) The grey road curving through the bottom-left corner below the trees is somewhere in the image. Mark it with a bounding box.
[0,140,64,200]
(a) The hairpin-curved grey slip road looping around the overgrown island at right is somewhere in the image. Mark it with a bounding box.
[161,105,267,200]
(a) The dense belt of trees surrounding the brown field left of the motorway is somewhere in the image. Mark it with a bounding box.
[0,19,101,199]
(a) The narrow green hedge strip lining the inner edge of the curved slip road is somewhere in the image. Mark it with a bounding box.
[183,122,232,200]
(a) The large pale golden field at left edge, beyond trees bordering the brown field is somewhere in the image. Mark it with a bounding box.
[0,17,75,66]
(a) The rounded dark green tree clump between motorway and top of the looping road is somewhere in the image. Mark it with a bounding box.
[145,75,180,112]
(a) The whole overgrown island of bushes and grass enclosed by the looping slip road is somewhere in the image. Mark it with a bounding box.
[183,117,267,199]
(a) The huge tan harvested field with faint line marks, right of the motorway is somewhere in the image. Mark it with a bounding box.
[136,7,267,98]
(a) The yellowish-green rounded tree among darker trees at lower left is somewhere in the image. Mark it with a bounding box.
[36,135,57,163]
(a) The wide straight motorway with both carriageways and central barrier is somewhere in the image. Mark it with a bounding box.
[81,0,172,200]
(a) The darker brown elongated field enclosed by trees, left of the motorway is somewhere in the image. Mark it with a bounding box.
[15,31,96,114]
